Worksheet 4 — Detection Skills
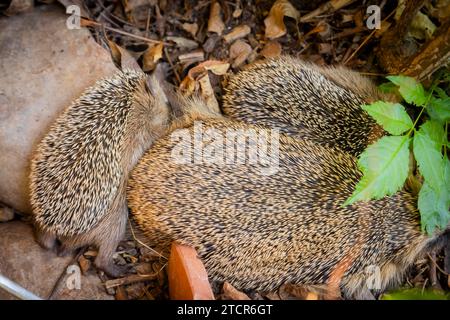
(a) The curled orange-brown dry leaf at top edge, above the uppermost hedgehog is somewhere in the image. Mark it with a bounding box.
[264,0,300,39]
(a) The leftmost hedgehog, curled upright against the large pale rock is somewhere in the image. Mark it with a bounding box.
[30,70,170,277]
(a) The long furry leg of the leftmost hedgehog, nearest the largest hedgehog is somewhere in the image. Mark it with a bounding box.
[94,196,130,278]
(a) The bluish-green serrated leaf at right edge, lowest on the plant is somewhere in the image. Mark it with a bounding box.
[418,180,450,235]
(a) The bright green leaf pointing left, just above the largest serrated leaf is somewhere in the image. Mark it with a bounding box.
[362,101,413,135]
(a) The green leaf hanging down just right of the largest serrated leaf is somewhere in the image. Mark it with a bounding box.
[413,120,446,190]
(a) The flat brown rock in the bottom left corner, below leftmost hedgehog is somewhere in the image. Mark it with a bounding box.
[0,221,113,300]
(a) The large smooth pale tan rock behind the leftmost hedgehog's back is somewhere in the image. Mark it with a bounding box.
[0,5,116,213]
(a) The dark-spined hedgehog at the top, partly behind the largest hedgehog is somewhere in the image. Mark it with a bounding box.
[223,56,393,155]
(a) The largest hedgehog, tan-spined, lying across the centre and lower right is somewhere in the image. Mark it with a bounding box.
[127,101,449,299]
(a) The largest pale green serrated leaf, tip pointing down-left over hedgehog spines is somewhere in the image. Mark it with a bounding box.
[344,136,411,206]
